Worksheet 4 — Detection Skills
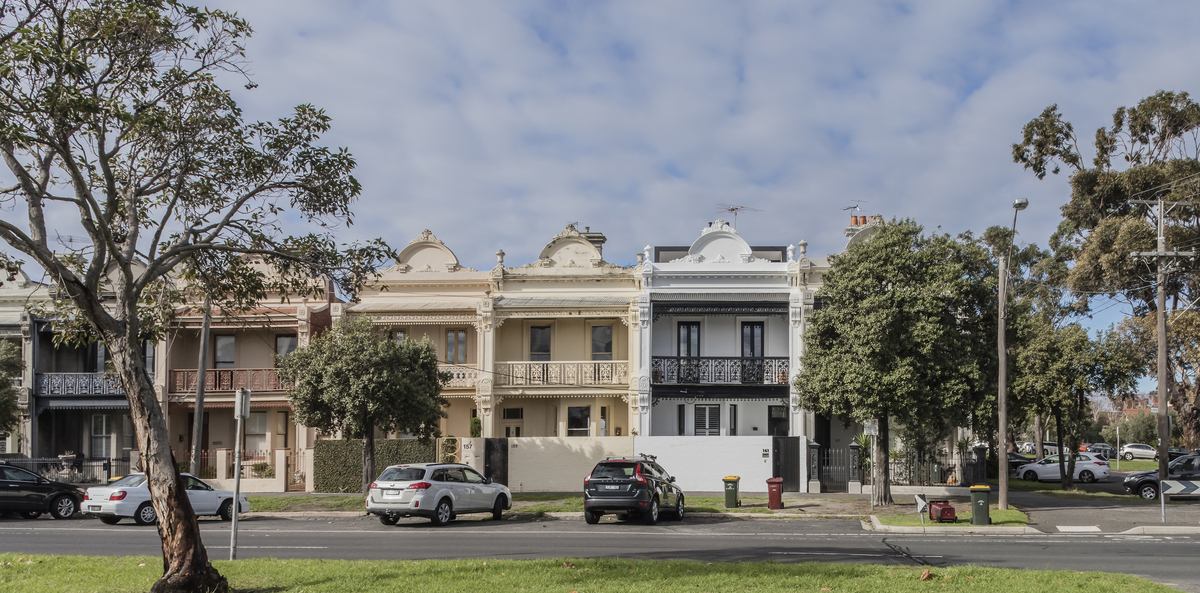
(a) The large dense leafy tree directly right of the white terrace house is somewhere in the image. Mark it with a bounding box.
[796,221,997,504]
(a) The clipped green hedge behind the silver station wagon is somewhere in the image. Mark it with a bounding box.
[312,438,437,492]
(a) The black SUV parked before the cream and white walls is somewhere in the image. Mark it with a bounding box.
[583,455,683,525]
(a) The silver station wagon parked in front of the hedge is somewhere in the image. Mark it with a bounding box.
[367,463,512,526]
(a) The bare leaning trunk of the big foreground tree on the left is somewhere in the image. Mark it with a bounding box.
[101,331,229,593]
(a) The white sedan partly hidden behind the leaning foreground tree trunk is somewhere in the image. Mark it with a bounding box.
[80,474,250,525]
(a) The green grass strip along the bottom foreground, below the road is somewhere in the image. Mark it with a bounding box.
[0,553,1175,593]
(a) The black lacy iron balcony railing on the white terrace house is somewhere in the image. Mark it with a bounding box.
[650,357,788,385]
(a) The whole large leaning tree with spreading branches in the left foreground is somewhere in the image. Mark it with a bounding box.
[0,0,394,592]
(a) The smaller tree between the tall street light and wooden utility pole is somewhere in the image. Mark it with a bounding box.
[1013,316,1140,489]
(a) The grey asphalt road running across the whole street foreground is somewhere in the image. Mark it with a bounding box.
[0,517,1200,593]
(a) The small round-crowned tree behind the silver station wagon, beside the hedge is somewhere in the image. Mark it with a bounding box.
[278,318,450,492]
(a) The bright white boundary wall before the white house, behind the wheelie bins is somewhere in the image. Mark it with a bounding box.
[634,436,772,492]
